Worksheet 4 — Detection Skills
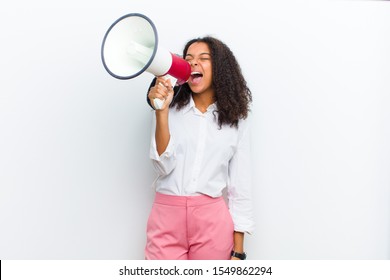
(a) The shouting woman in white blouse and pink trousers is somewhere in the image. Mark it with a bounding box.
[145,37,254,259]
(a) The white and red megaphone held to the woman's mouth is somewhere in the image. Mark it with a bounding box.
[101,13,191,109]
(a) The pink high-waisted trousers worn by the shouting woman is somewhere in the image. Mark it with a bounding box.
[145,193,234,260]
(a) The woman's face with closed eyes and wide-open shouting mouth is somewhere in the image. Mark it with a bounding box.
[185,42,213,93]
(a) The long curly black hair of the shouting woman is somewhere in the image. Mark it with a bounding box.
[171,36,252,128]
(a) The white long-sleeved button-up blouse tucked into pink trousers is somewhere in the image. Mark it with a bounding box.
[150,98,254,233]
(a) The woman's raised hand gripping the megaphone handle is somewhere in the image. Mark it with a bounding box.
[148,77,173,111]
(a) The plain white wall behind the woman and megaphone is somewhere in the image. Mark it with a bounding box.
[0,0,390,259]
